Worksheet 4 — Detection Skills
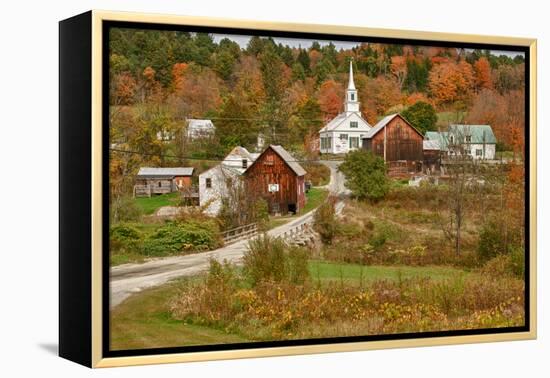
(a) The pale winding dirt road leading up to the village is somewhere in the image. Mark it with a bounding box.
[110,161,347,308]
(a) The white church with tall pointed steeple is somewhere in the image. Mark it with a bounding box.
[319,62,372,154]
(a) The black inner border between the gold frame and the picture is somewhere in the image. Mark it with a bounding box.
[101,20,532,358]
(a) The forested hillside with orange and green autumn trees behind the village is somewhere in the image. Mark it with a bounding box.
[110,29,525,190]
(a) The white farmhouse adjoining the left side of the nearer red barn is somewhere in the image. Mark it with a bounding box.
[199,146,255,216]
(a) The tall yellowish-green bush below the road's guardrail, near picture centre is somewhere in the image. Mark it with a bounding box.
[243,234,309,286]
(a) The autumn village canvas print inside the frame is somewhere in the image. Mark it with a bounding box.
[106,26,528,351]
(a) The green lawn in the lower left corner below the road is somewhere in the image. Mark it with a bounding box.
[111,281,248,350]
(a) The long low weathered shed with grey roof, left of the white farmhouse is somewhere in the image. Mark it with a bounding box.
[134,167,194,197]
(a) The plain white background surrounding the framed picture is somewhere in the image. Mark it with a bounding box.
[0,0,550,378]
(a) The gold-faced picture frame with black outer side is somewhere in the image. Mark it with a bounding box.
[60,10,537,368]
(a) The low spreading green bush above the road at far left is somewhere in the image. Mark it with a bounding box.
[142,220,222,256]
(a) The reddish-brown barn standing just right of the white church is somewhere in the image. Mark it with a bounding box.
[363,114,424,174]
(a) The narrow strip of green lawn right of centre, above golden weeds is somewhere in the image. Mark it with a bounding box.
[309,260,469,284]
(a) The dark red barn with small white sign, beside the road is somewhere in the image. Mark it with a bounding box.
[244,145,306,214]
